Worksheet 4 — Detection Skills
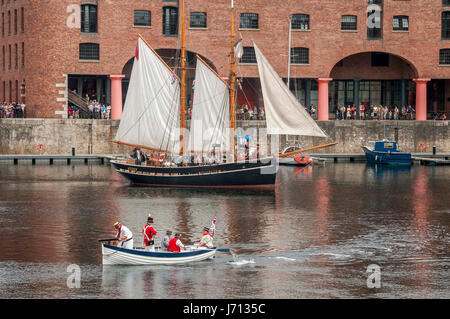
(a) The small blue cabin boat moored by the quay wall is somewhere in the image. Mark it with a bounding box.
[362,141,412,165]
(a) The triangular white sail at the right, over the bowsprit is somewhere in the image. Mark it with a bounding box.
[253,43,327,137]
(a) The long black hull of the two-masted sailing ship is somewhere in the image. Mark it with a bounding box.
[111,160,277,188]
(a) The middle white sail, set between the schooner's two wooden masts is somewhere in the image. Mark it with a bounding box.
[187,59,230,152]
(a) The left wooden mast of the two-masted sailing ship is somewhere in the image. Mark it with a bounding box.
[180,0,186,155]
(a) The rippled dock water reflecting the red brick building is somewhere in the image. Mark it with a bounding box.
[0,163,450,299]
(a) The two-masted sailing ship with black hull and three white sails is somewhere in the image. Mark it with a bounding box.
[111,1,326,188]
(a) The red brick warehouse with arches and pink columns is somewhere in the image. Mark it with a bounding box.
[0,0,450,120]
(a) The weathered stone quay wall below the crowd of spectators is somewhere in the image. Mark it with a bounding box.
[0,119,450,155]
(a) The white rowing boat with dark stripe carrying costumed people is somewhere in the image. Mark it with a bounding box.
[102,243,217,265]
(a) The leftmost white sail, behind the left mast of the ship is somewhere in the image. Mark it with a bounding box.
[116,38,180,153]
